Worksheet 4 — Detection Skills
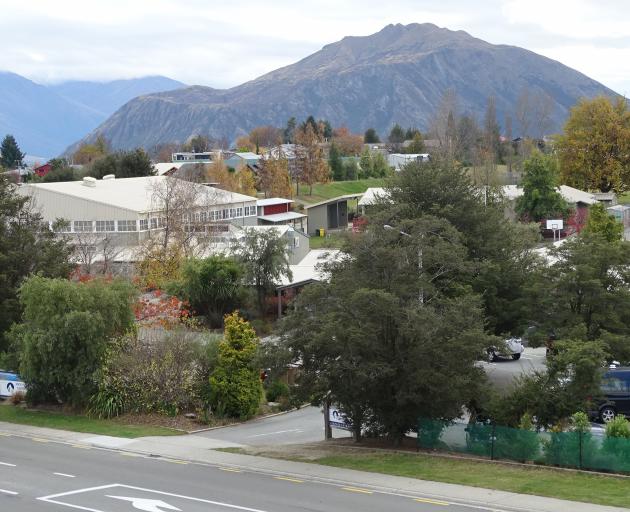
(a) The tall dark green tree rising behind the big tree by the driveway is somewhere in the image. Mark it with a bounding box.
[390,160,540,335]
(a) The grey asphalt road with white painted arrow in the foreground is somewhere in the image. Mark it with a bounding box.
[0,437,498,512]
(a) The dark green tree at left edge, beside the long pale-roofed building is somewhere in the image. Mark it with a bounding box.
[0,175,73,353]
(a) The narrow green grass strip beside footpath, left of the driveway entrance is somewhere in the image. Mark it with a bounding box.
[0,405,181,438]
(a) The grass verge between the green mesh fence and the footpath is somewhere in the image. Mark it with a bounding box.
[226,450,630,507]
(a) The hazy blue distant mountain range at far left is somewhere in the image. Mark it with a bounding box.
[0,72,184,157]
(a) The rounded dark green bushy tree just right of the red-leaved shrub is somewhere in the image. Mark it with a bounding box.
[177,256,243,327]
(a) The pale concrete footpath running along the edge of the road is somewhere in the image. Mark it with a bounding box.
[0,422,630,512]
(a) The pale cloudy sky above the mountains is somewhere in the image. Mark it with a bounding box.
[0,0,630,95]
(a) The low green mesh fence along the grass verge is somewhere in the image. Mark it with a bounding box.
[417,418,630,473]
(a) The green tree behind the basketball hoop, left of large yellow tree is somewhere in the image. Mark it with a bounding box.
[516,153,569,222]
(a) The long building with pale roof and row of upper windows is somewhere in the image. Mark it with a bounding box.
[18,176,257,246]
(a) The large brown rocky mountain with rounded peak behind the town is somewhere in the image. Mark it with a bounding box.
[70,24,615,152]
